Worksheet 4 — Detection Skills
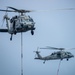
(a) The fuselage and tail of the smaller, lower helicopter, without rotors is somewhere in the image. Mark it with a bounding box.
[35,51,74,61]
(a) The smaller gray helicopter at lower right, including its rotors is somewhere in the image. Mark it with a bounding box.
[34,46,75,63]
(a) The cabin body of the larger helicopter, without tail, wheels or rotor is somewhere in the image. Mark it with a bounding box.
[8,15,35,34]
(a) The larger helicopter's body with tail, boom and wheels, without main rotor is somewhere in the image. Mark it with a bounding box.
[0,14,35,40]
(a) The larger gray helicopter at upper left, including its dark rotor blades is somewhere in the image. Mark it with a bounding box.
[0,7,35,40]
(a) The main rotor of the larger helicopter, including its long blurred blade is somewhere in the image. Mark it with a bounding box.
[0,6,75,13]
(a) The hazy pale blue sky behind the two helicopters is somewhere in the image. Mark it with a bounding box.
[0,0,75,75]
